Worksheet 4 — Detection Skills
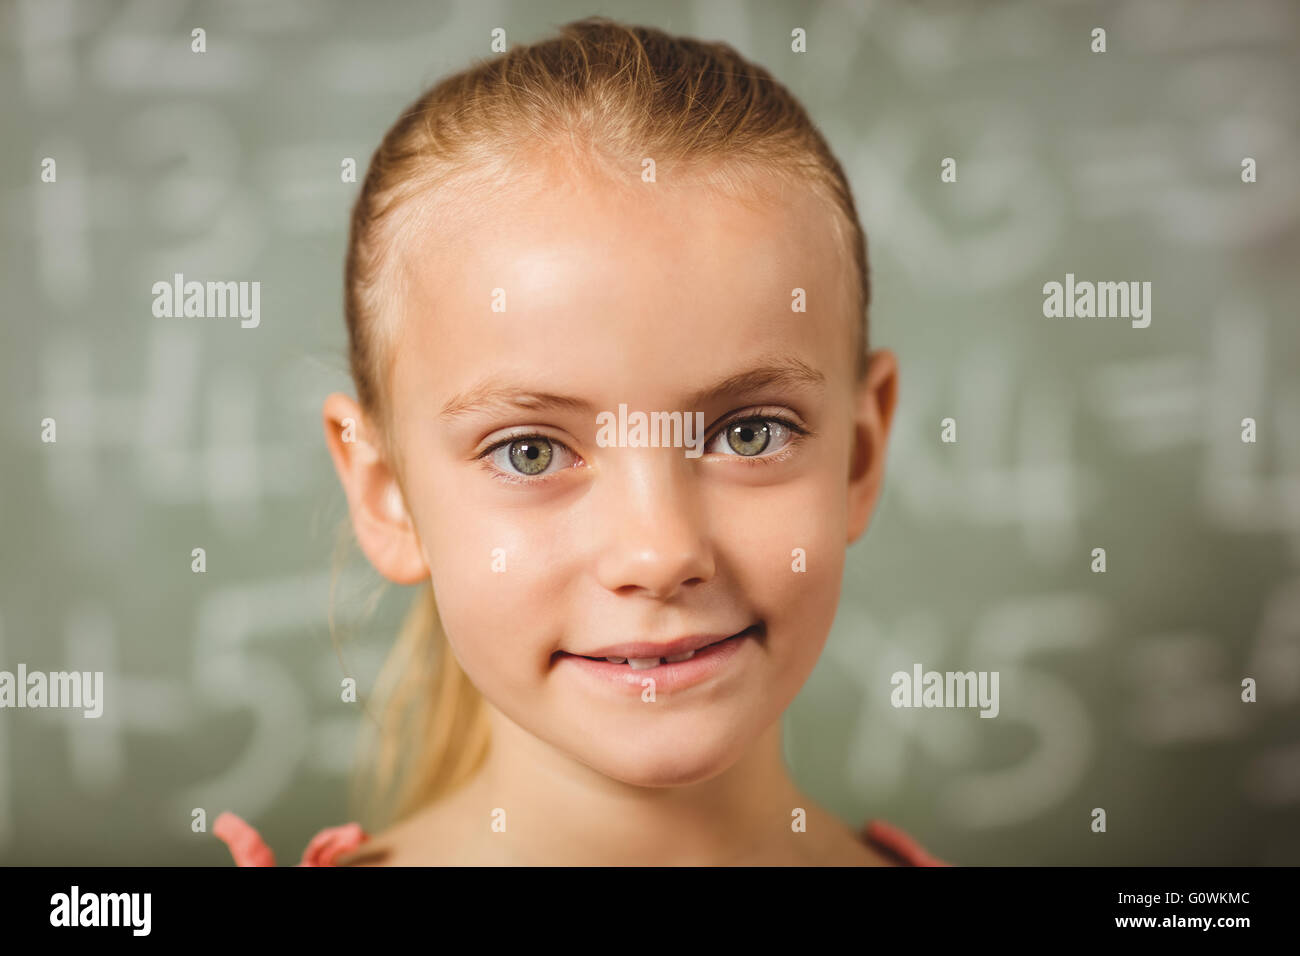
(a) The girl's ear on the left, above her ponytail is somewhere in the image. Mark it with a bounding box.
[321,392,429,584]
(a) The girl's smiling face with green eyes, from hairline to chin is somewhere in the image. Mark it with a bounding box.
[326,167,896,786]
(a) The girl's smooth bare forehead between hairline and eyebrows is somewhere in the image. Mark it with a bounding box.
[391,163,854,412]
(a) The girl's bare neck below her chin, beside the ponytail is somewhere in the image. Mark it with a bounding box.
[456,704,806,866]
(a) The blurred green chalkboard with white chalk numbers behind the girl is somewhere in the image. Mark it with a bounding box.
[0,0,1300,865]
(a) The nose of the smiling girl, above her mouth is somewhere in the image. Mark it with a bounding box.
[594,447,715,600]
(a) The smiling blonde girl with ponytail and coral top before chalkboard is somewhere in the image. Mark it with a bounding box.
[215,18,939,865]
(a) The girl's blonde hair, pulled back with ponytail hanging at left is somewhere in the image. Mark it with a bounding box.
[345,17,871,819]
